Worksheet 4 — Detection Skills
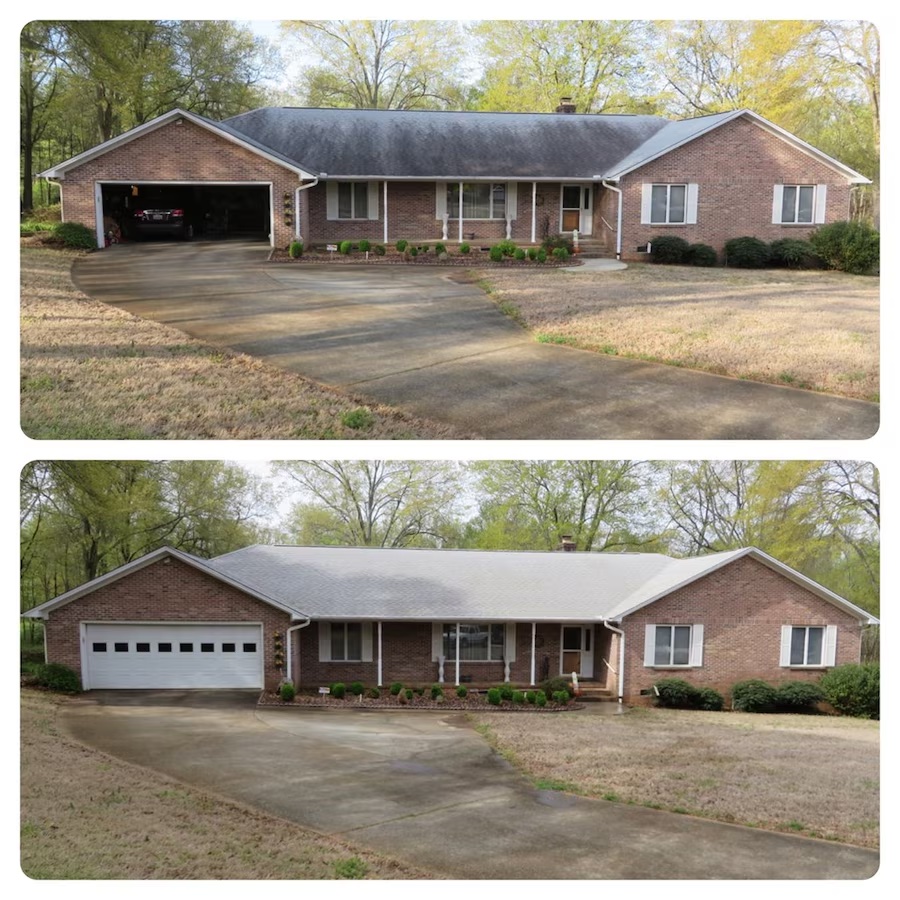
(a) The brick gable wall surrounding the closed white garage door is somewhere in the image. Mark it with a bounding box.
[46,559,290,688]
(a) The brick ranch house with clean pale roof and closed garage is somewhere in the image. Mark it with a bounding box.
[25,545,877,702]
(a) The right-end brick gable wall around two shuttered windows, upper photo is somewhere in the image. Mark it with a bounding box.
[607,119,850,259]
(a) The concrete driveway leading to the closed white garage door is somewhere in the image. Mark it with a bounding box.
[62,691,878,880]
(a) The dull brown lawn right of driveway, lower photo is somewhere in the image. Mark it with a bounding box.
[470,709,880,847]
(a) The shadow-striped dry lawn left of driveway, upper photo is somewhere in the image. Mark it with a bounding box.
[21,242,468,440]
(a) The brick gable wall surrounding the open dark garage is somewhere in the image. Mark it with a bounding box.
[61,120,299,247]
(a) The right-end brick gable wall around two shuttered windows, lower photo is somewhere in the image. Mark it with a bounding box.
[614,557,861,702]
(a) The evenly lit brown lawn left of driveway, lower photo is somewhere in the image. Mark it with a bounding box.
[20,690,430,879]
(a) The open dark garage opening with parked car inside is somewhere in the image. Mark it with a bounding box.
[101,181,272,243]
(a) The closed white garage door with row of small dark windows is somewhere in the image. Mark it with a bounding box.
[82,624,263,688]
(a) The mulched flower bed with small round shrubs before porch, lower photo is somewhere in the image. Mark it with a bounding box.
[259,682,583,712]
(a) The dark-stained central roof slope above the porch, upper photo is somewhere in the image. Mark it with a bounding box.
[219,107,668,179]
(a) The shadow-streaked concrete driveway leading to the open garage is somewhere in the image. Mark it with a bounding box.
[74,243,879,440]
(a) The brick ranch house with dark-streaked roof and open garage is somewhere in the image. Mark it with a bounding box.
[41,106,868,259]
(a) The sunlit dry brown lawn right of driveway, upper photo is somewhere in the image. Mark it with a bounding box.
[480,264,879,400]
